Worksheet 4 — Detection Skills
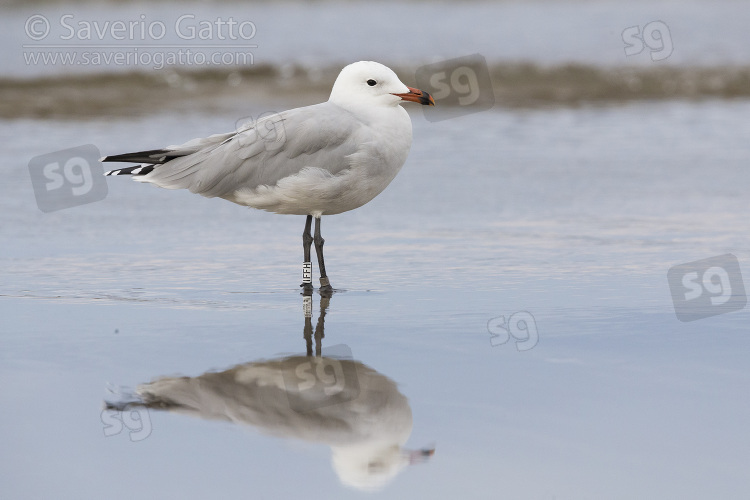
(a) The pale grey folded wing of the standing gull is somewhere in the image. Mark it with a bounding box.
[136,102,365,197]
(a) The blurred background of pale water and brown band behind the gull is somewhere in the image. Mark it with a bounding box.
[8,0,750,119]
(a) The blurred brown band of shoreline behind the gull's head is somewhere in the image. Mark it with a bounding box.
[0,63,750,119]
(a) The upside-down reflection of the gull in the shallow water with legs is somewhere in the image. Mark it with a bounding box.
[106,295,434,491]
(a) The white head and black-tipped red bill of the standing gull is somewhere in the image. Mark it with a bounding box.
[328,61,435,108]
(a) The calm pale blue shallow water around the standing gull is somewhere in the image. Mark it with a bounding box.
[0,101,750,498]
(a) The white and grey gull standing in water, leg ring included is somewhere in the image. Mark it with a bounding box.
[101,61,435,296]
